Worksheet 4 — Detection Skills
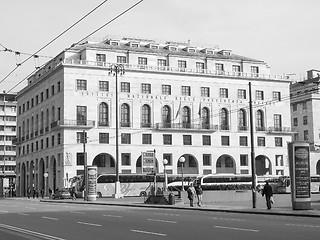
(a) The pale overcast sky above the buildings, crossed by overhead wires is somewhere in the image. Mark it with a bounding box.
[0,0,320,92]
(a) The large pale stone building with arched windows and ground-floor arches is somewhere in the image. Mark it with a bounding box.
[17,38,292,195]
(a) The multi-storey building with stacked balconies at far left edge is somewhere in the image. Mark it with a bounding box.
[0,92,17,196]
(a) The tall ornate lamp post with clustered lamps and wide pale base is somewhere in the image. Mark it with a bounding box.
[109,63,124,198]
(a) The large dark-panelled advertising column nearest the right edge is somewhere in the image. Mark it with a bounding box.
[288,142,311,210]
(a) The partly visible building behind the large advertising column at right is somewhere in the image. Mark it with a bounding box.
[290,70,320,175]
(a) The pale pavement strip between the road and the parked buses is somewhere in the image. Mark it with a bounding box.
[40,194,320,218]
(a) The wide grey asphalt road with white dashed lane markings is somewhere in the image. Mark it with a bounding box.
[0,199,320,240]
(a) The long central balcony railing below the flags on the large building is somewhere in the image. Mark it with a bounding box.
[155,123,218,131]
